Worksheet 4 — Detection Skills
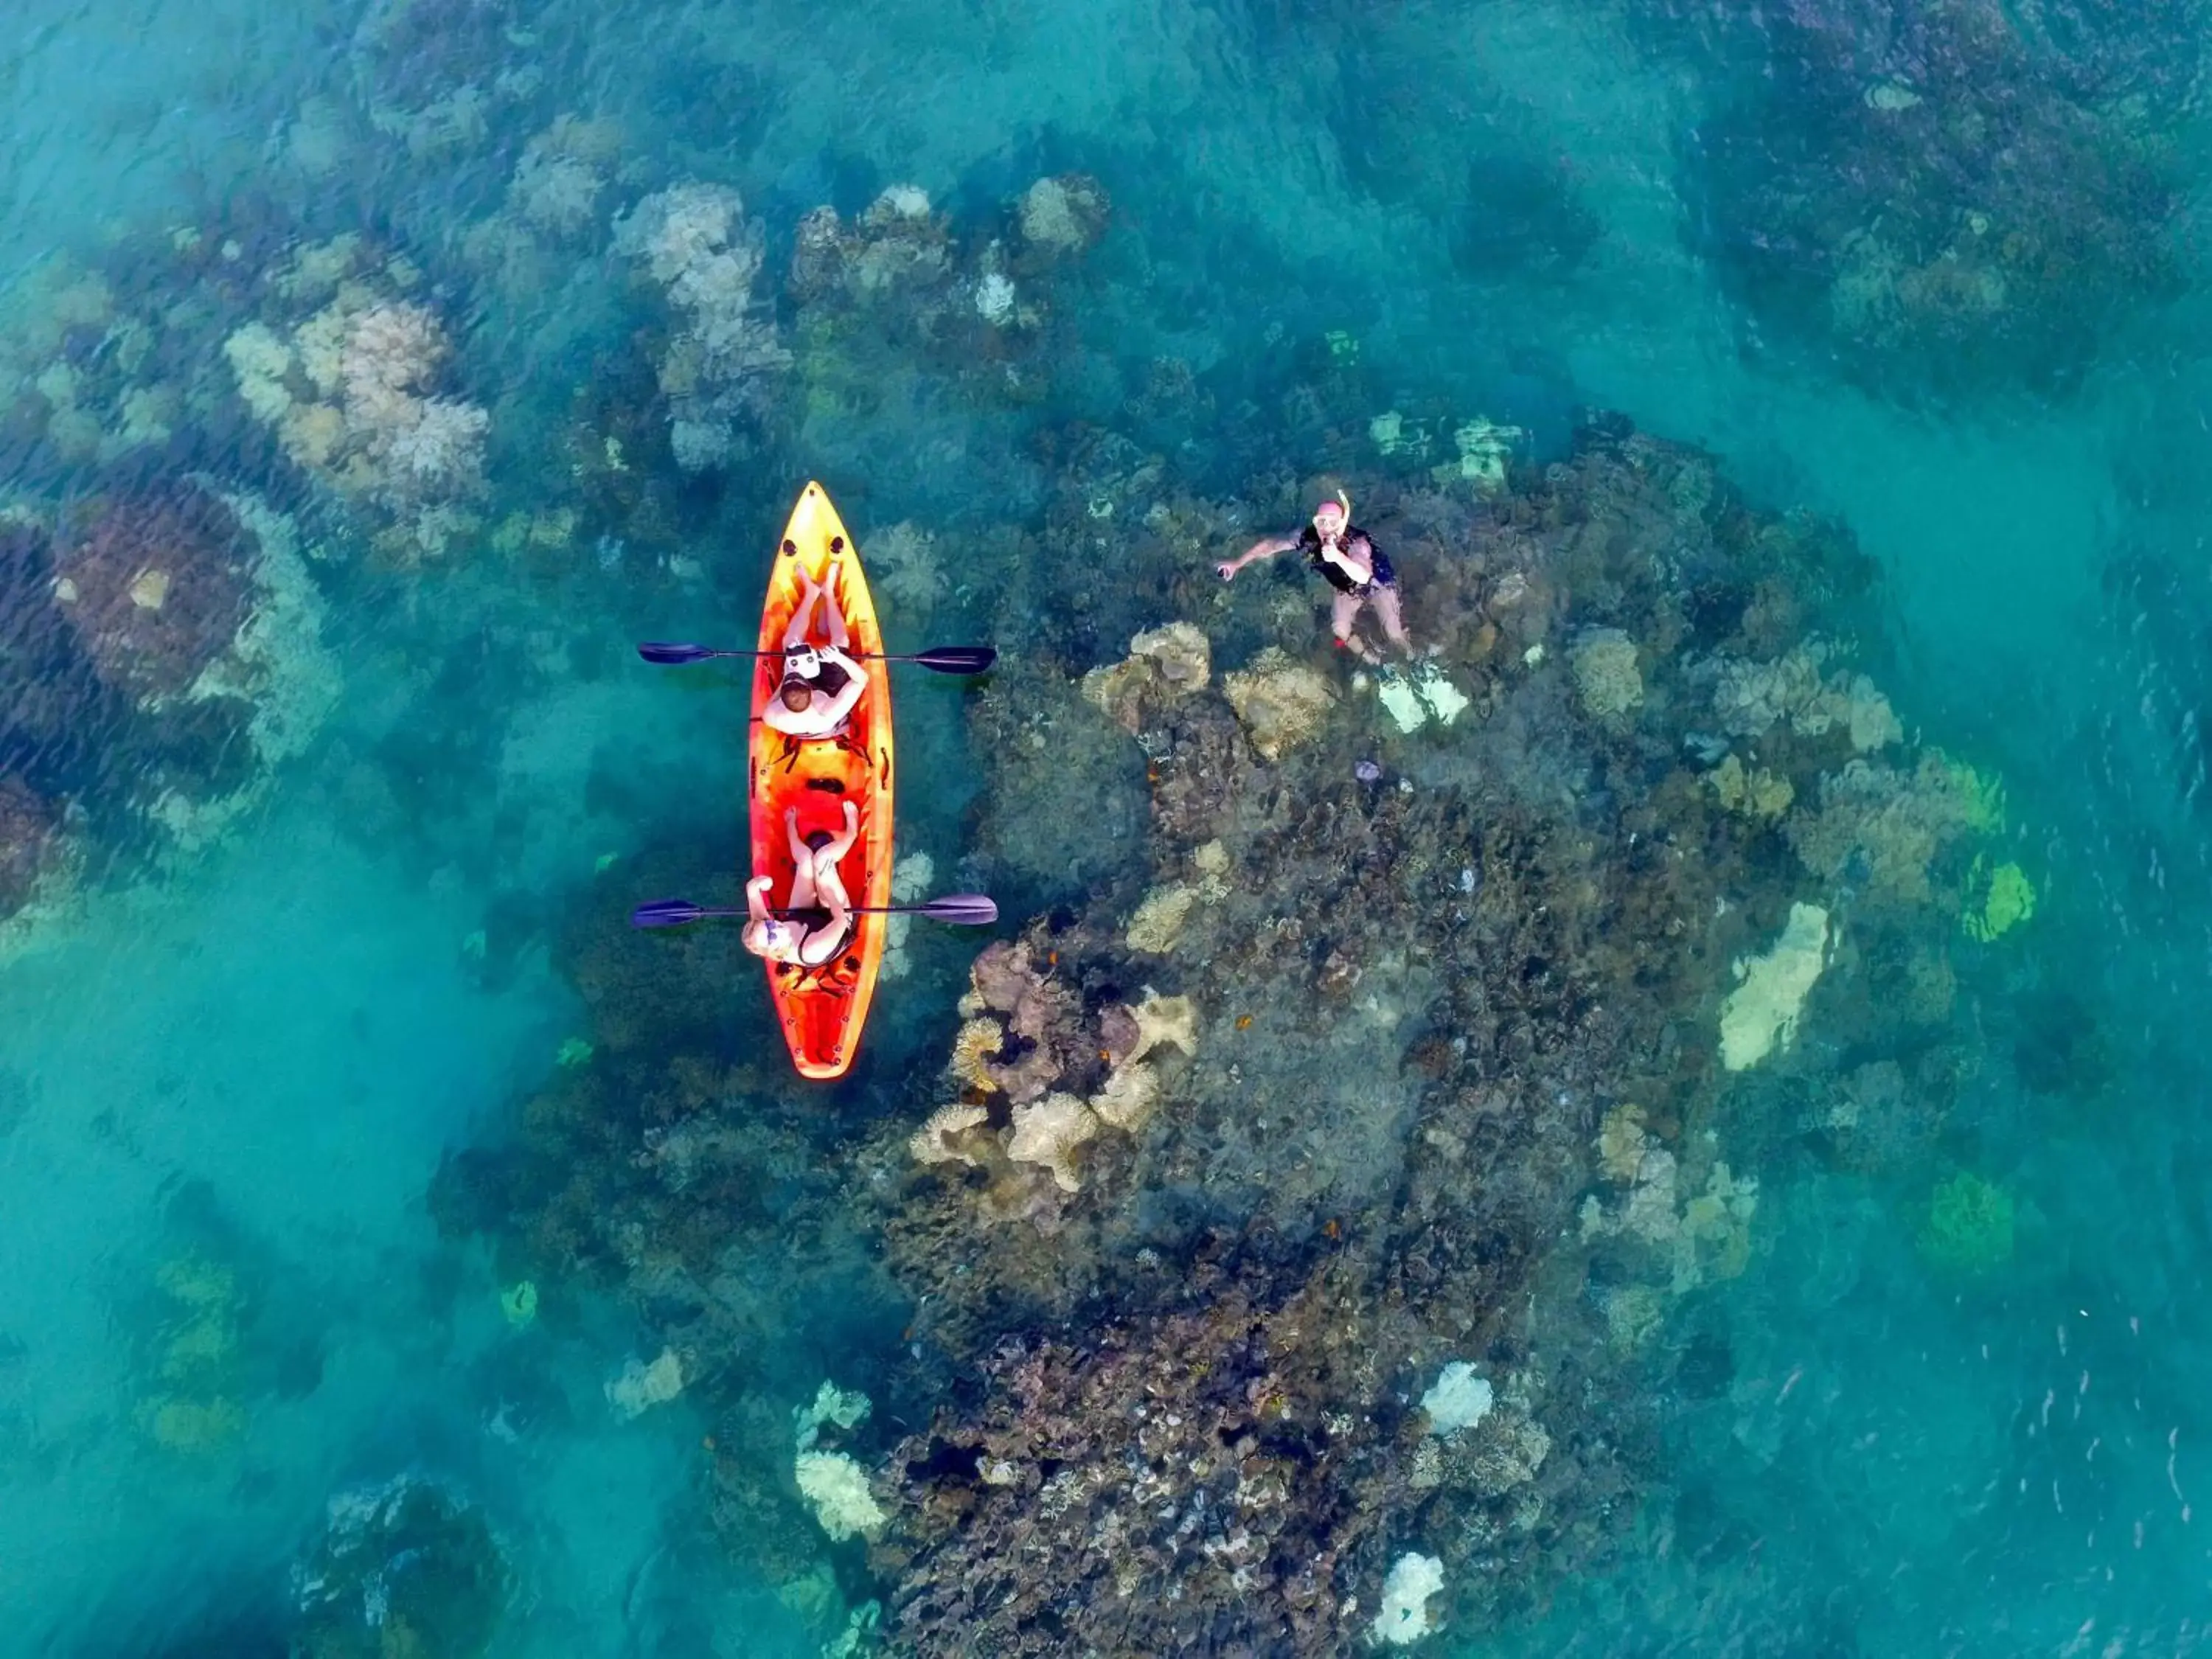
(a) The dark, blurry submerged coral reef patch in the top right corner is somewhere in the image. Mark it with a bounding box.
[1652,0,2194,396]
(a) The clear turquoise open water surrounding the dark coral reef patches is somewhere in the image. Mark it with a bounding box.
[0,4,2212,1652]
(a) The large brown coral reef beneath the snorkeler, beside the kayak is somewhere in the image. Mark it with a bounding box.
[434,394,1993,1657]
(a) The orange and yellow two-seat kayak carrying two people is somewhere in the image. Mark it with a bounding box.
[748,482,891,1082]
